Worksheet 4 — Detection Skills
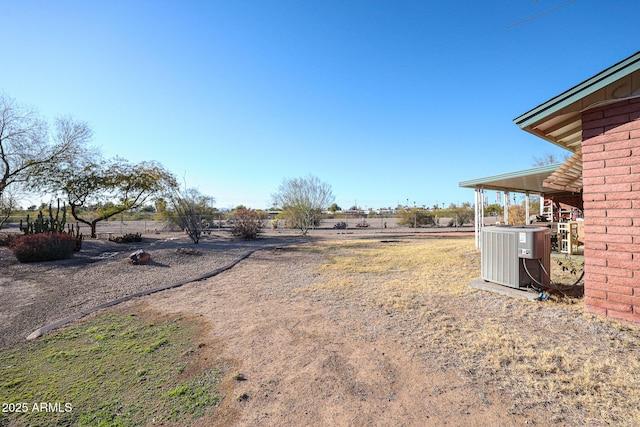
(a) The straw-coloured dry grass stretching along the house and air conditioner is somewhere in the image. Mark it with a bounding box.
[298,238,640,425]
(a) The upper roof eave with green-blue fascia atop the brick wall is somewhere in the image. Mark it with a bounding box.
[513,52,640,152]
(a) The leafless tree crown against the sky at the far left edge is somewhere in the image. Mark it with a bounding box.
[0,94,93,201]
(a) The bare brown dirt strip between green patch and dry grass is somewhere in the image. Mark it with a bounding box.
[135,246,525,426]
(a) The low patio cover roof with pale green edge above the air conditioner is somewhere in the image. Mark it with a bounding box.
[458,163,566,194]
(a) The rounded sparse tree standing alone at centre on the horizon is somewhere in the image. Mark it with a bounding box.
[272,175,334,235]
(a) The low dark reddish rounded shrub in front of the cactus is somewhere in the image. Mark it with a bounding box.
[9,233,77,262]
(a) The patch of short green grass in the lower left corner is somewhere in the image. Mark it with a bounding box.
[0,314,220,426]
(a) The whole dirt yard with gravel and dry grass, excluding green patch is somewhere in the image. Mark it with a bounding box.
[0,231,640,426]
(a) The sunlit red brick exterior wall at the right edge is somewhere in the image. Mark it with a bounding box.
[582,99,640,323]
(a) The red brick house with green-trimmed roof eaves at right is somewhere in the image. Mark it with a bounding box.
[514,52,640,323]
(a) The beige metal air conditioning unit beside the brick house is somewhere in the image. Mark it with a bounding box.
[481,226,551,288]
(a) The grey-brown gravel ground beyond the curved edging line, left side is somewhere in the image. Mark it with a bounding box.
[0,233,298,348]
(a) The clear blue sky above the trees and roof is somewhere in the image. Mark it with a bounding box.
[0,0,640,208]
